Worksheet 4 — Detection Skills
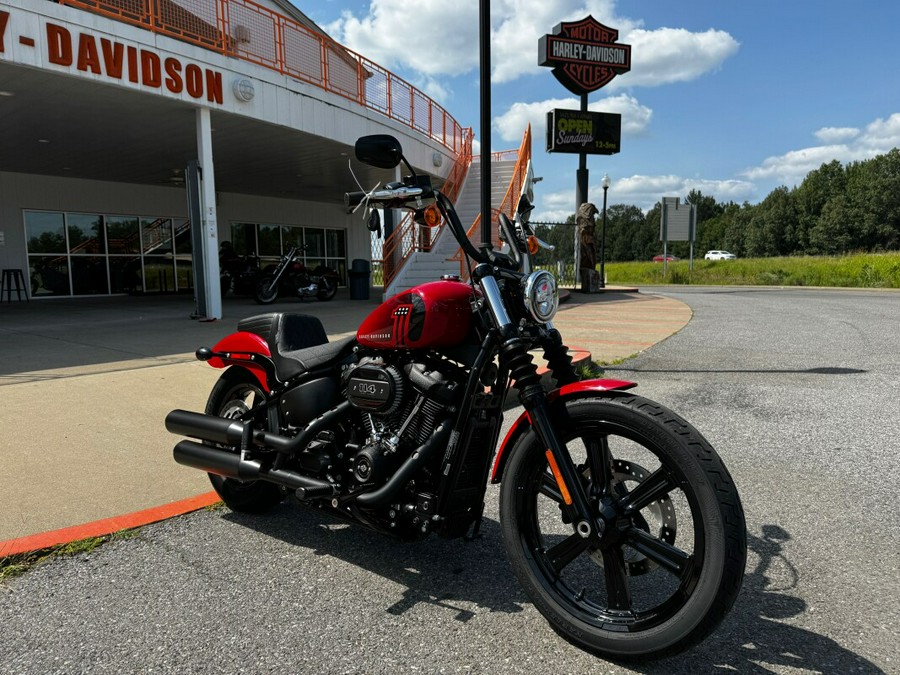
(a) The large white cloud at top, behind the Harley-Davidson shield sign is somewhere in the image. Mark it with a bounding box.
[325,0,739,87]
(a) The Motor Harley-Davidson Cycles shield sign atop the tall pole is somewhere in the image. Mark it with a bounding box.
[538,15,631,95]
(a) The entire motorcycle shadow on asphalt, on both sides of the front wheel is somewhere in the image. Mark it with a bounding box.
[223,510,884,675]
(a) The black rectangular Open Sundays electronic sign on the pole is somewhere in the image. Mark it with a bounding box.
[547,109,622,155]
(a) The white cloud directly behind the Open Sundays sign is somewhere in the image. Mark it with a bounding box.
[493,94,653,142]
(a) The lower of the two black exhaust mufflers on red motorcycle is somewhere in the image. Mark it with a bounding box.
[167,440,334,499]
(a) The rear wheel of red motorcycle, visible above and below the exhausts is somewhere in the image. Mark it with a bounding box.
[206,367,284,513]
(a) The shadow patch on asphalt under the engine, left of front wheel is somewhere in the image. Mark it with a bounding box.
[223,502,528,622]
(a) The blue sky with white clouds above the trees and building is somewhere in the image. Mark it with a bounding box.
[294,0,900,221]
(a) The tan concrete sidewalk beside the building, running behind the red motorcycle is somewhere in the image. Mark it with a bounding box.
[0,289,691,557]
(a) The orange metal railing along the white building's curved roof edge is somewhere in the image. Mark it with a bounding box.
[59,0,471,153]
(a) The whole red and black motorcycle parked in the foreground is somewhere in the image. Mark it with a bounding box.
[166,136,746,660]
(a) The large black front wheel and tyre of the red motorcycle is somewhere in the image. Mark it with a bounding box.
[500,395,747,660]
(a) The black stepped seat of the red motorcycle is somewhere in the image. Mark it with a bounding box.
[238,312,356,382]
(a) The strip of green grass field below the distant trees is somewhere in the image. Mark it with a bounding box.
[606,252,900,288]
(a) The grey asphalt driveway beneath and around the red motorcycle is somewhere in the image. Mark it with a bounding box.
[0,289,900,674]
